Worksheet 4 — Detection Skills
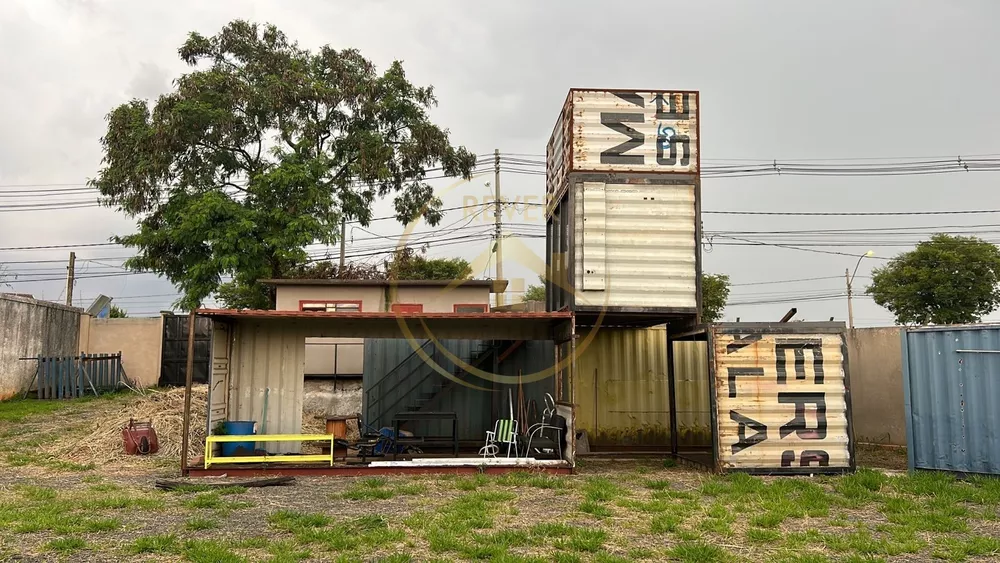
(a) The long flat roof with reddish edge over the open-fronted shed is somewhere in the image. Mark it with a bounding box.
[197,309,574,342]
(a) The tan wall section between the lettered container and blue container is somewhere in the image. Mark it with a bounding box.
[847,327,906,446]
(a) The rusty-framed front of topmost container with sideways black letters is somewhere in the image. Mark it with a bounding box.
[564,91,698,174]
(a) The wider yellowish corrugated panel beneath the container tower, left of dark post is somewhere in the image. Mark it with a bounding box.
[574,327,670,447]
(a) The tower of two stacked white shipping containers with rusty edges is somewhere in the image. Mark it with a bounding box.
[546,90,701,326]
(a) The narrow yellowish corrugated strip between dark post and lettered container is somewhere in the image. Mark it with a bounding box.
[673,342,712,448]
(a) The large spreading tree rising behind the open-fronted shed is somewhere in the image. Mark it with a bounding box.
[91,20,476,308]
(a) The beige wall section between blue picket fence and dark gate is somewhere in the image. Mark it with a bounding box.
[79,315,163,387]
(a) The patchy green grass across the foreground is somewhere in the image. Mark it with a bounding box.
[0,394,1000,563]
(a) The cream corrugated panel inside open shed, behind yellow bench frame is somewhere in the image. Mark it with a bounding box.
[229,320,306,453]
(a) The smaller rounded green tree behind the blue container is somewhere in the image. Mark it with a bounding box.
[865,234,1000,325]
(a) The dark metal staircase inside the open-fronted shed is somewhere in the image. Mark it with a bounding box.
[365,340,516,428]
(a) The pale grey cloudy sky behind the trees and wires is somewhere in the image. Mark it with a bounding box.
[0,0,1000,326]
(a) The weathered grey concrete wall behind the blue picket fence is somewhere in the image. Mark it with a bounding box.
[0,295,82,399]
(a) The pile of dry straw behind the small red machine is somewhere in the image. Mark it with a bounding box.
[45,385,208,465]
